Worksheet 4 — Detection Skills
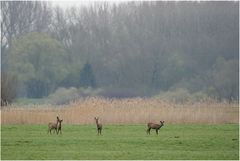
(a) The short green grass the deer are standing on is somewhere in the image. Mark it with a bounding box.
[1,124,239,160]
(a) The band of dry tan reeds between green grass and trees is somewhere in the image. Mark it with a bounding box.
[1,98,239,124]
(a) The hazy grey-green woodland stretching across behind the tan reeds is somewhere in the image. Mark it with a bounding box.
[1,1,239,104]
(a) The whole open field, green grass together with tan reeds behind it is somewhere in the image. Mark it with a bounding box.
[1,98,239,160]
